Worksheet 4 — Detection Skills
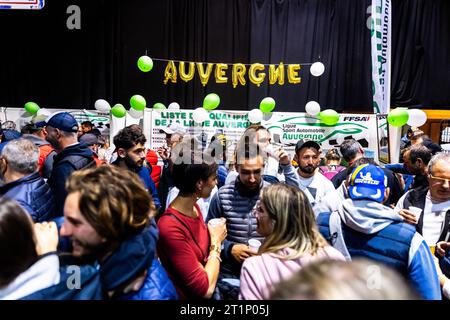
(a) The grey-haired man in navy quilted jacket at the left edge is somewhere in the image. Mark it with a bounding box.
[0,139,54,222]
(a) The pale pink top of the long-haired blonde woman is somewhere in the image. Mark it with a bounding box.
[239,246,345,300]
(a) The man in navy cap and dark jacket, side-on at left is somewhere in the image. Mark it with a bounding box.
[45,112,95,217]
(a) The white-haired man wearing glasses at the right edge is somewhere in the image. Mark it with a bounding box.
[395,153,450,253]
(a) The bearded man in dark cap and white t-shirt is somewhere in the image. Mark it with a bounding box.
[295,139,337,213]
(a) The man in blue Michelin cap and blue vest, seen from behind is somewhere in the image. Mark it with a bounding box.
[317,164,441,300]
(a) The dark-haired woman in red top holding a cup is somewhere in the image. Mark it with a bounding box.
[158,149,227,300]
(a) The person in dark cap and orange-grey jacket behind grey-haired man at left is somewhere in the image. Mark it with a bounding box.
[21,118,56,179]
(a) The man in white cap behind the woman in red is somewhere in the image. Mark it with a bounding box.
[156,122,186,213]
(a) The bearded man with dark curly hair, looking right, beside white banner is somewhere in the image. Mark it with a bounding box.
[112,125,161,209]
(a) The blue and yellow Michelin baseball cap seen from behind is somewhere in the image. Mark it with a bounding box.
[349,163,387,202]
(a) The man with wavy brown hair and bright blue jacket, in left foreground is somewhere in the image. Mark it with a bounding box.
[60,166,177,300]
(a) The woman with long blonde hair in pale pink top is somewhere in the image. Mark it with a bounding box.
[239,184,345,300]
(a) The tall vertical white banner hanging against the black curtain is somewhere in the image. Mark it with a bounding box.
[371,0,392,114]
